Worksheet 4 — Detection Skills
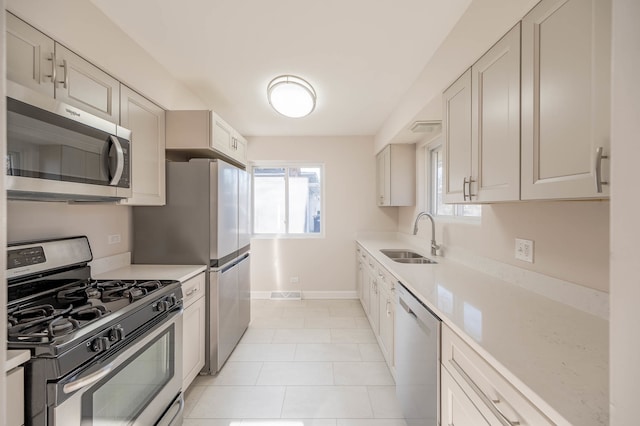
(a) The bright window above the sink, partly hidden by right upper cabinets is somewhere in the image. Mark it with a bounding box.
[425,145,482,218]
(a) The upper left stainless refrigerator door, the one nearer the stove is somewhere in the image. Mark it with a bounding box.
[210,160,239,259]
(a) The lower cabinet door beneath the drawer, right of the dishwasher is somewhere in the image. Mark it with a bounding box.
[440,368,490,426]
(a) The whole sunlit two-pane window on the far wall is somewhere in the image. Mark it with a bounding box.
[253,164,324,238]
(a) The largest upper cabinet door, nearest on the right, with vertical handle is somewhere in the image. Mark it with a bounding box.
[522,0,611,200]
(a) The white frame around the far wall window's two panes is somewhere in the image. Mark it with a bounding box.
[251,161,327,239]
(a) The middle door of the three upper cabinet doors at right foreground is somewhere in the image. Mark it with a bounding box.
[470,24,520,202]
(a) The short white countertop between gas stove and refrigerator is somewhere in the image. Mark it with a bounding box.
[92,264,207,282]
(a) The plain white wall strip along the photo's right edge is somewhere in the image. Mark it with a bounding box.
[610,0,640,426]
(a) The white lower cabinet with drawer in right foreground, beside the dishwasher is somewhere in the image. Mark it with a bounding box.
[440,324,554,426]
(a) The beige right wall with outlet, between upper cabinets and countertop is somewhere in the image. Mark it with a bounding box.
[398,140,609,292]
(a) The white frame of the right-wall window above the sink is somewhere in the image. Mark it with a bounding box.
[423,141,482,223]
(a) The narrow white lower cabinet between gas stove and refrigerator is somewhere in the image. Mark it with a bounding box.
[182,273,206,391]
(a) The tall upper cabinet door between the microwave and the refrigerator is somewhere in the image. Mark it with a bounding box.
[120,86,165,206]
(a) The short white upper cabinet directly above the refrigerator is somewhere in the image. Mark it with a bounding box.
[167,110,247,166]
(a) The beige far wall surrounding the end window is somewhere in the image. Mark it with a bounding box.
[248,136,397,296]
